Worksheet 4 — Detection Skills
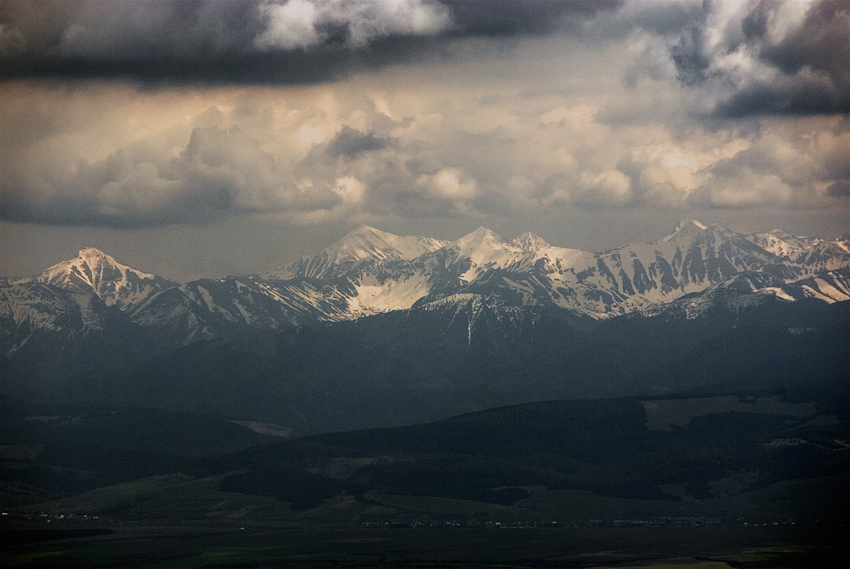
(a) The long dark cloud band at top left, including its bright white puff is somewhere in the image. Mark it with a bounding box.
[0,0,619,84]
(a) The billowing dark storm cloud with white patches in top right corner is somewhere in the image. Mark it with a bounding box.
[670,0,850,117]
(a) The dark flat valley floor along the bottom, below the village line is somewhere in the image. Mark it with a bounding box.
[0,522,850,569]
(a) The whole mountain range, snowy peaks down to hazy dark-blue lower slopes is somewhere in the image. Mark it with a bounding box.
[0,220,850,432]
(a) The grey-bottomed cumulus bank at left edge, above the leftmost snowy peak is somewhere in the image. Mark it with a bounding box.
[0,123,342,227]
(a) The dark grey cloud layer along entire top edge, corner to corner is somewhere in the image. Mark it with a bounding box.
[0,0,850,118]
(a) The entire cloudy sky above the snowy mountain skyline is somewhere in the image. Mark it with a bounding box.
[0,0,850,281]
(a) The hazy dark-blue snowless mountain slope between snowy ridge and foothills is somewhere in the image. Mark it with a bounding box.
[18,293,850,434]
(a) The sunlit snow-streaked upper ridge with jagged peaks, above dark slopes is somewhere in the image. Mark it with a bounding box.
[0,220,850,353]
